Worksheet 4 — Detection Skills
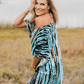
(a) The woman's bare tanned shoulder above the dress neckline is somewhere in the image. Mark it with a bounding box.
[35,14,52,28]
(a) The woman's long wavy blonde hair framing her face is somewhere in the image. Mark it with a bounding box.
[28,0,58,28]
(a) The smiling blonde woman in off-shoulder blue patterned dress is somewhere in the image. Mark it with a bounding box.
[13,0,63,84]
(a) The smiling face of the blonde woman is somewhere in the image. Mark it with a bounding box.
[35,0,50,16]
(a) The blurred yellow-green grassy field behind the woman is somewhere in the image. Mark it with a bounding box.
[0,24,84,84]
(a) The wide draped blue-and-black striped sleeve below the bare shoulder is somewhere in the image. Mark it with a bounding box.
[34,27,50,58]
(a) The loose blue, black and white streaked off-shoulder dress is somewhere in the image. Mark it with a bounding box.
[24,20,63,84]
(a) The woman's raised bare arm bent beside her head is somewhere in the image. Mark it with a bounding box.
[12,7,30,28]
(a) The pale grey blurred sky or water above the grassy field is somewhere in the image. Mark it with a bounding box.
[0,0,84,28]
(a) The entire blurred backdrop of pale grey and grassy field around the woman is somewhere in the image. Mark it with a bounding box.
[0,0,84,84]
